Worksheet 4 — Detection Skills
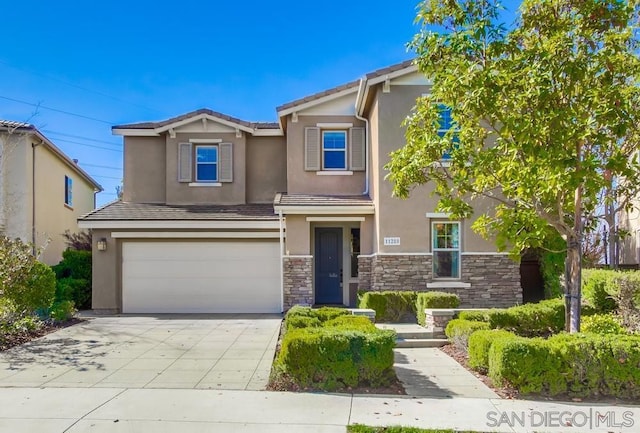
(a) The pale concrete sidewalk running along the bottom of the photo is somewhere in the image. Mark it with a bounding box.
[0,388,640,433]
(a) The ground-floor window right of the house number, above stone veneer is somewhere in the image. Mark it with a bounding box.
[431,221,460,278]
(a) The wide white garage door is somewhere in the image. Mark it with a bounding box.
[122,241,281,313]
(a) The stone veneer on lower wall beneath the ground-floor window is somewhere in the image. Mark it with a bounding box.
[358,254,522,308]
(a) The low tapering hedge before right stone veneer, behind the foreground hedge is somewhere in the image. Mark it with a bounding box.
[459,299,593,337]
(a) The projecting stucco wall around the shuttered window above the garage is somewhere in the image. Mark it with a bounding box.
[166,133,246,204]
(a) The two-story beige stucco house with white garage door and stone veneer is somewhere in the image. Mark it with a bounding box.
[80,62,522,313]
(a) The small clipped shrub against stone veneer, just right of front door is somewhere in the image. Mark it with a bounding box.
[358,291,416,322]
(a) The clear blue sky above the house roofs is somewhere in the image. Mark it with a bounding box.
[0,0,520,205]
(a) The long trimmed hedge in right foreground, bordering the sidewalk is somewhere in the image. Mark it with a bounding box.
[489,334,640,399]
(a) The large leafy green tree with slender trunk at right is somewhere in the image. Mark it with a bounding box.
[387,0,640,332]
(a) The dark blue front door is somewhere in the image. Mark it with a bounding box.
[315,227,342,304]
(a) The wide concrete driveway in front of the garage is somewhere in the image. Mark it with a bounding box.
[0,314,281,390]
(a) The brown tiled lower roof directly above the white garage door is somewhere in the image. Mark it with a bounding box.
[80,201,278,221]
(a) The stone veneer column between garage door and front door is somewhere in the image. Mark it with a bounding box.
[282,256,313,311]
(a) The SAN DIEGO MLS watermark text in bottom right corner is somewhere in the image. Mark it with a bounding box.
[487,408,635,431]
